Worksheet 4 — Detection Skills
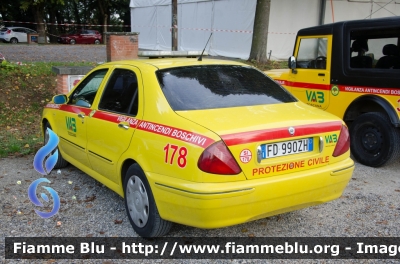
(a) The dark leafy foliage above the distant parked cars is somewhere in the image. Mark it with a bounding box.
[0,0,130,42]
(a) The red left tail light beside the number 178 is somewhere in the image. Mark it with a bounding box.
[197,141,242,175]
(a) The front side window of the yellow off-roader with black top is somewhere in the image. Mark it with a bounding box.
[296,38,328,69]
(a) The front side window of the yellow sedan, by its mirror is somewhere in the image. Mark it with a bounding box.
[68,69,108,107]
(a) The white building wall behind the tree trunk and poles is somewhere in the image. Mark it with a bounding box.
[130,0,400,60]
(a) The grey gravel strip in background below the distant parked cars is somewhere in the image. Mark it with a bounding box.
[0,43,107,63]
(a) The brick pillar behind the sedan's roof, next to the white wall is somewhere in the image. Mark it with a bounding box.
[105,32,139,62]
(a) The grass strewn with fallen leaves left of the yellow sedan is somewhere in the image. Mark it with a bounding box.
[0,62,96,158]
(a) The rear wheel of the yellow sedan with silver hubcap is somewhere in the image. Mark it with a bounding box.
[124,164,172,238]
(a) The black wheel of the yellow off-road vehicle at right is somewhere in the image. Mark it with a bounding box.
[350,112,400,167]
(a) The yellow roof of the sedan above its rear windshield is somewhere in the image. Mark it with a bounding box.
[100,58,249,69]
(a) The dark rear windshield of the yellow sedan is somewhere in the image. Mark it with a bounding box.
[157,65,297,111]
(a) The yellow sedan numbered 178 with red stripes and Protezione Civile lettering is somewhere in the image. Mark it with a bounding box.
[42,58,354,237]
